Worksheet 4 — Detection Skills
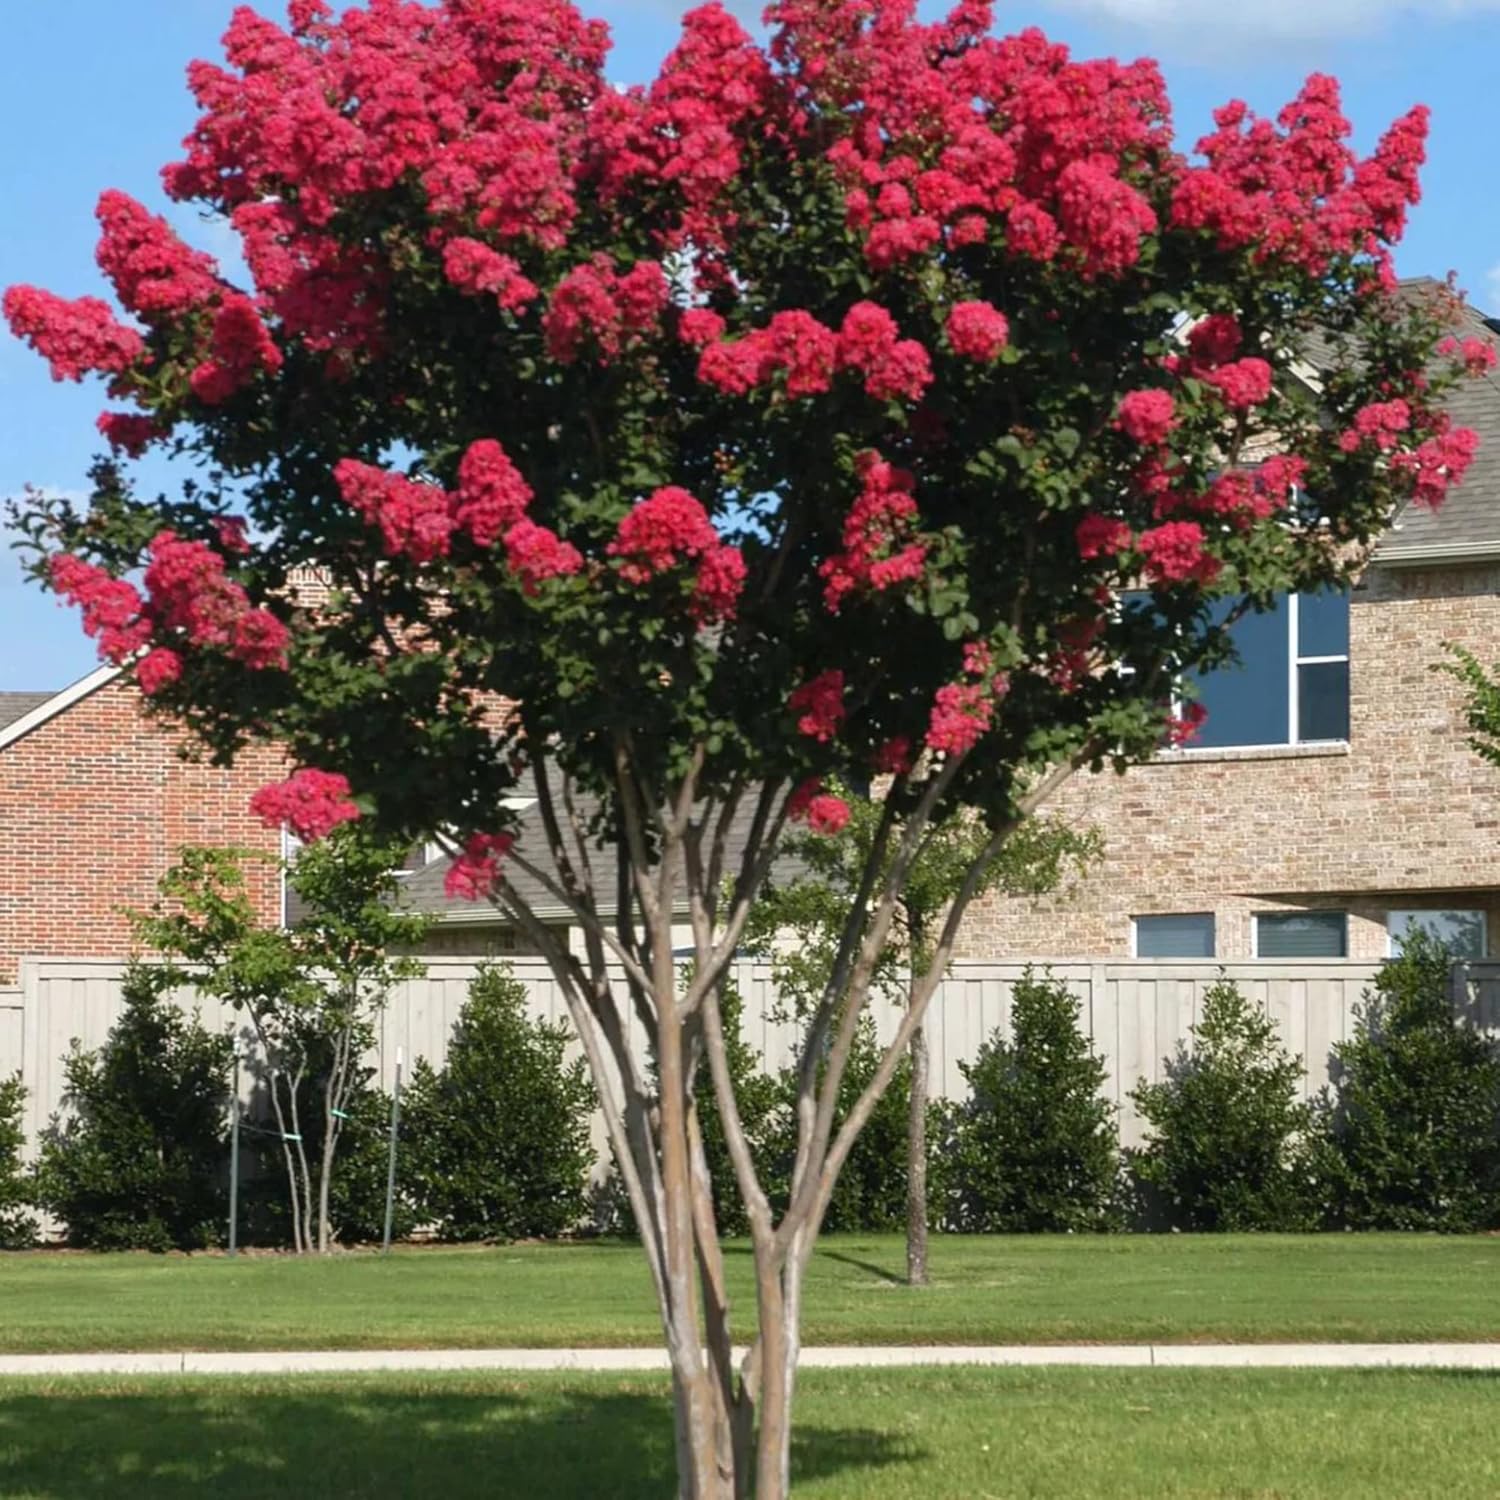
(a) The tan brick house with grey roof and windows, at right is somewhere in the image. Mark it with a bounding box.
[962,295,1500,959]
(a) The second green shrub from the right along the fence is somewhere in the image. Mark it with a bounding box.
[1131,983,1316,1230]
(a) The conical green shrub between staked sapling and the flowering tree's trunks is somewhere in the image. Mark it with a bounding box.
[402,968,596,1241]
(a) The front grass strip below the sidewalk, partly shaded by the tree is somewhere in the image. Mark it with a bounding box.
[0,1370,1500,1500]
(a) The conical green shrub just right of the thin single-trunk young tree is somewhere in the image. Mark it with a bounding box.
[950,969,1119,1235]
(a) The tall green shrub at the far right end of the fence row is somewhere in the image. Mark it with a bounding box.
[1319,932,1500,1233]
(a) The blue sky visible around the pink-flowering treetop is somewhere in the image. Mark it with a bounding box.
[0,0,1500,692]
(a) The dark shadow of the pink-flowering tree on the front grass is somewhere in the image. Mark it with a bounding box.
[0,1376,921,1500]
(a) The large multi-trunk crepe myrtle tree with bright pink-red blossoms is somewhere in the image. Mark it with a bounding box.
[5,0,1475,1500]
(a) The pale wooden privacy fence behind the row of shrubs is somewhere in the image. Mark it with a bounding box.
[11,959,1500,1146]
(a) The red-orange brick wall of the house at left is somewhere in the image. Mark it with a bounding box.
[0,683,284,984]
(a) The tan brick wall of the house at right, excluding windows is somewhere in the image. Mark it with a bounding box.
[960,566,1500,959]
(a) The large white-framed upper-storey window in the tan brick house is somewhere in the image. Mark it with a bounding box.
[1193,590,1349,750]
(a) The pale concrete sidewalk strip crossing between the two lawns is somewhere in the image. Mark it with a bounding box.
[0,1344,1500,1376]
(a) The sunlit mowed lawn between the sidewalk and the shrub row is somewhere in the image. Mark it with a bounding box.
[0,1235,1500,1353]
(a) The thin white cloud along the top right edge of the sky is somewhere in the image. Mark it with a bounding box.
[1052,0,1500,56]
